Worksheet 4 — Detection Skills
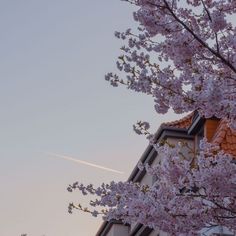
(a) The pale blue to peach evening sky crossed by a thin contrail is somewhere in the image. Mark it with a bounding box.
[0,0,180,236]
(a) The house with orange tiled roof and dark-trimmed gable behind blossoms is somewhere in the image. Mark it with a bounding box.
[96,112,236,236]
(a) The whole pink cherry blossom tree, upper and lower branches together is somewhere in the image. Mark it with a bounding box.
[68,0,236,235]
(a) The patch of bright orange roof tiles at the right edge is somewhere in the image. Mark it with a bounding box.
[212,119,236,156]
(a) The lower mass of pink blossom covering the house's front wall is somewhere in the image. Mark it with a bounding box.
[68,141,236,235]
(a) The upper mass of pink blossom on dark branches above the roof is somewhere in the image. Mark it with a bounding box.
[105,0,236,129]
